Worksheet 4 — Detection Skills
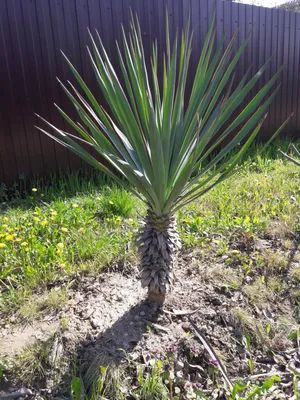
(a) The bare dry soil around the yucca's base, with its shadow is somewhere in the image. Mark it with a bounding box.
[0,237,300,399]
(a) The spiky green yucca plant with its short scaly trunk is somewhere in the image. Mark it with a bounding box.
[38,15,286,302]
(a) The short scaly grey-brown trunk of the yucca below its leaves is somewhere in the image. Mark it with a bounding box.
[137,210,180,304]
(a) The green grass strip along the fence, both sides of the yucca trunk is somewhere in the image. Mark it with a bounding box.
[0,141,300,311]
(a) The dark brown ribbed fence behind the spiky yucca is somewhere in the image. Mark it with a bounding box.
[0,0,300,185]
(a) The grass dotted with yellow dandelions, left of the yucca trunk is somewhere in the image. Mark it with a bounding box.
[0,183,137,311]
